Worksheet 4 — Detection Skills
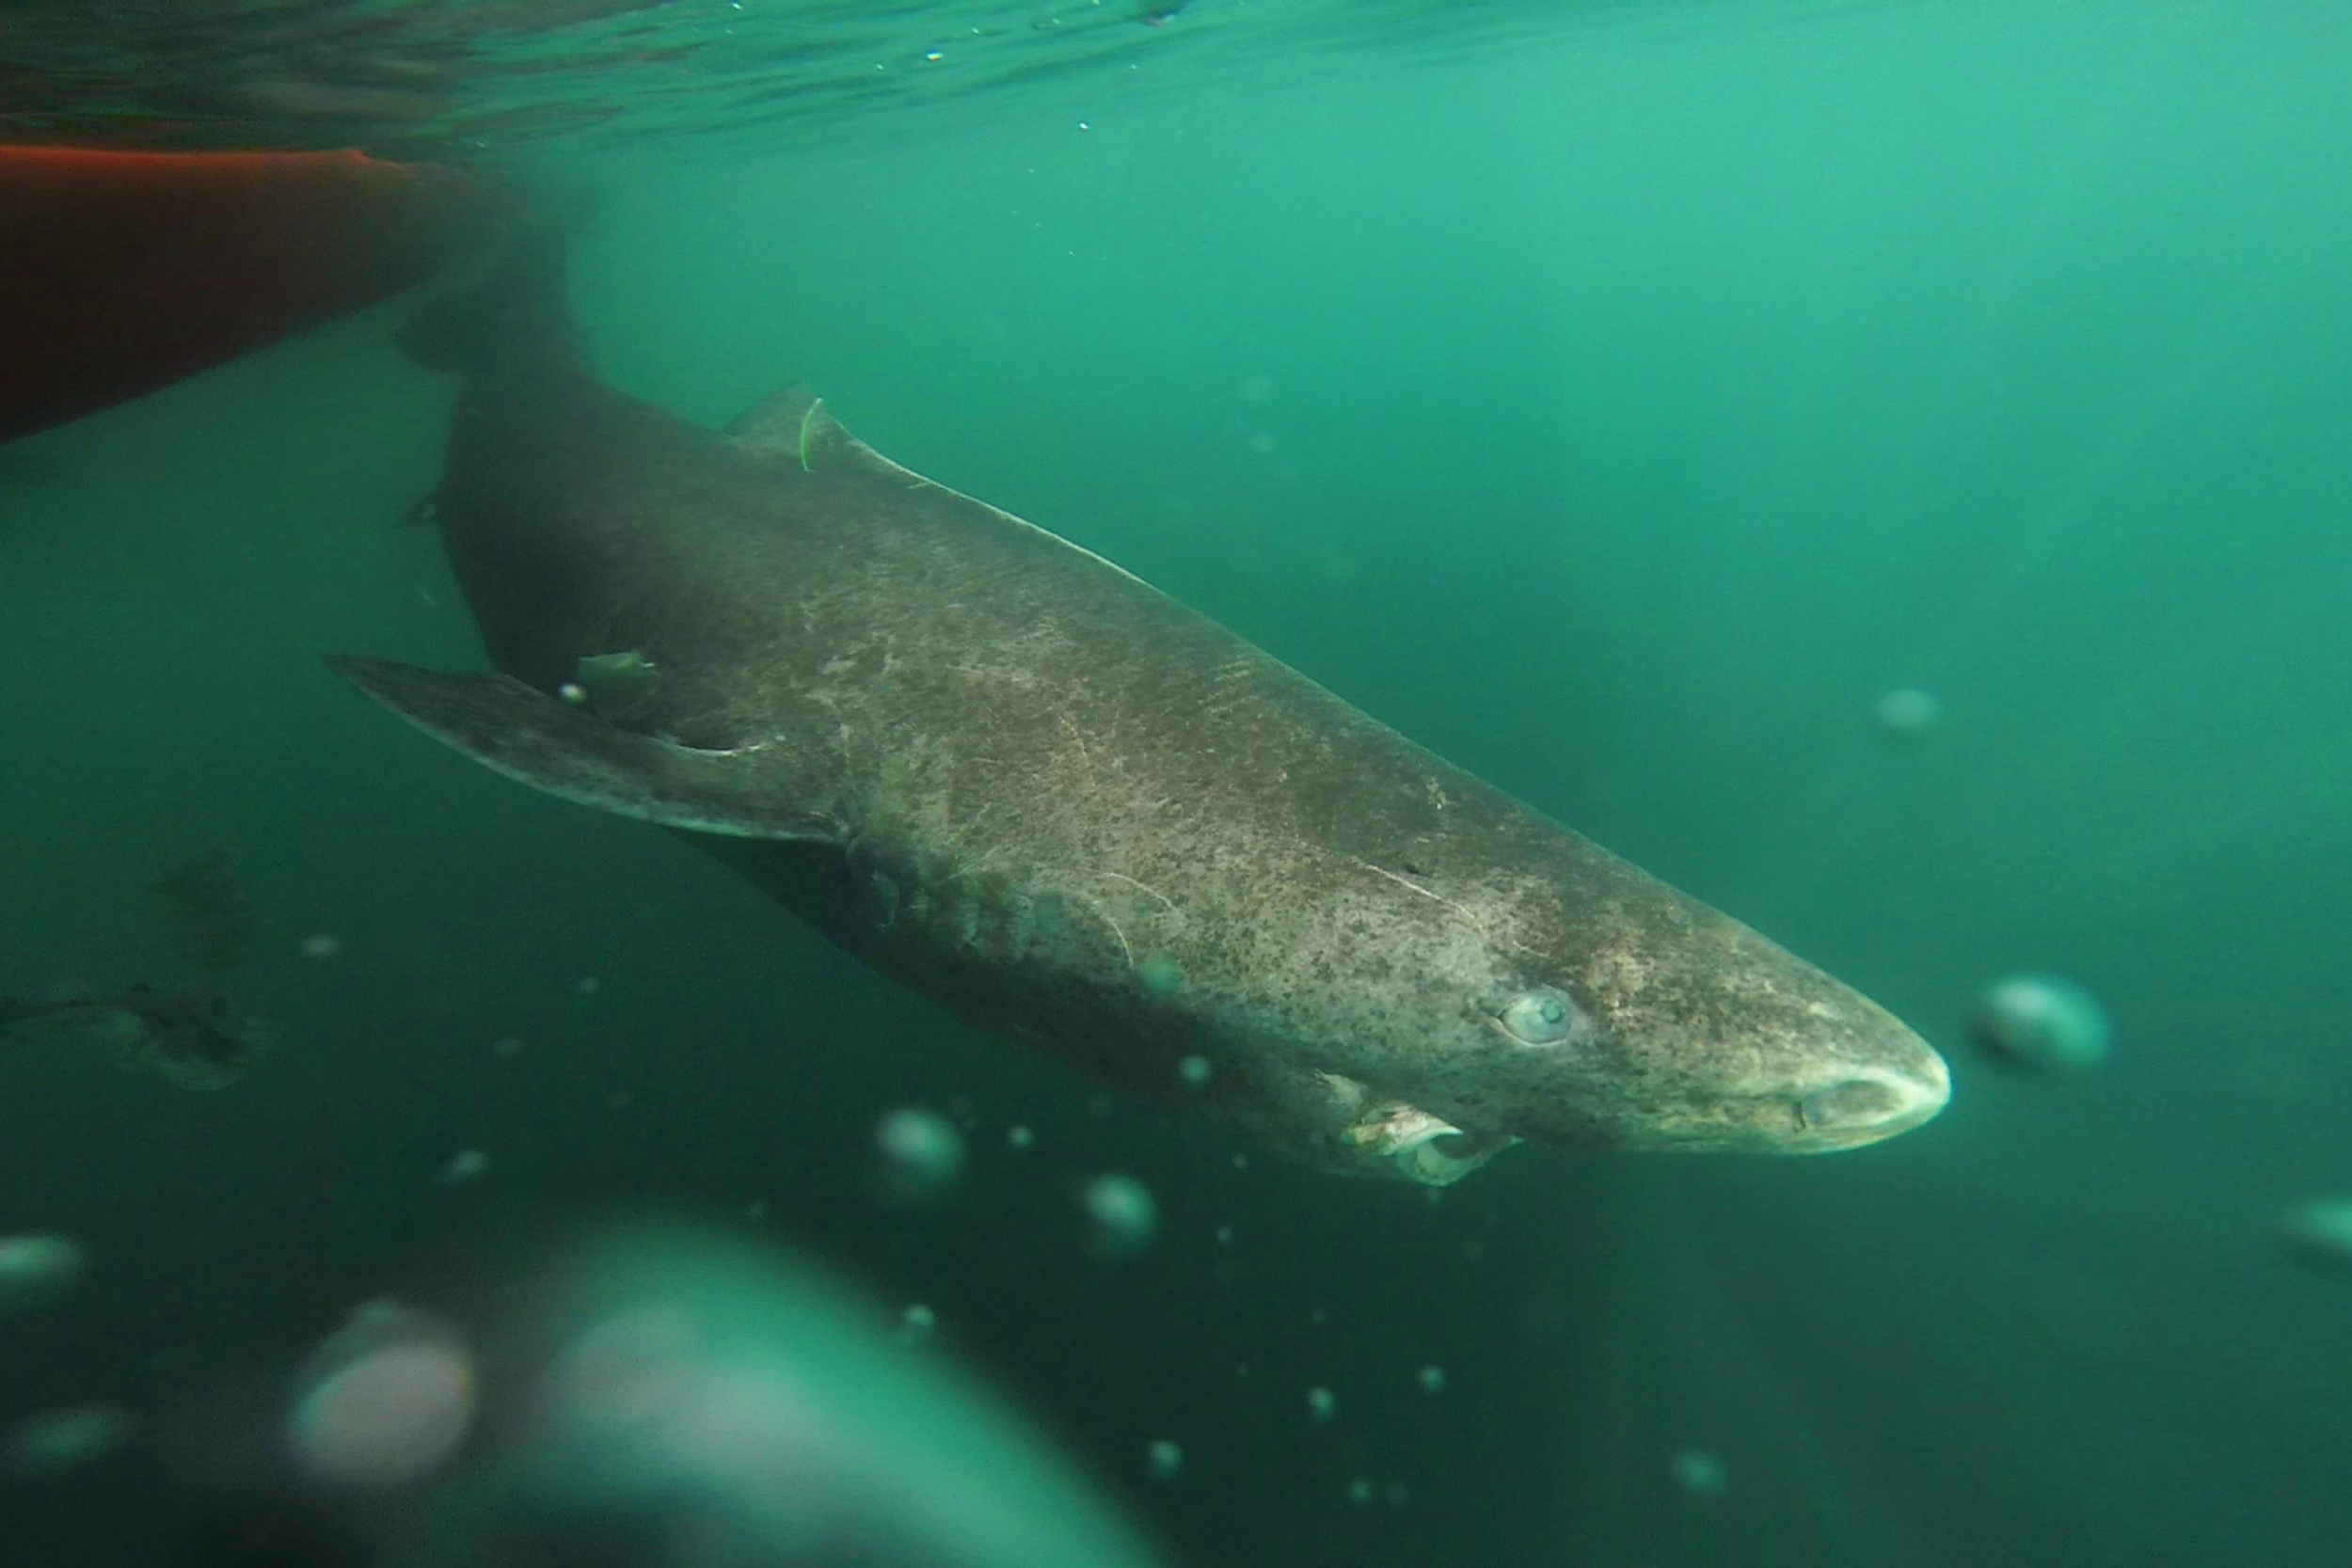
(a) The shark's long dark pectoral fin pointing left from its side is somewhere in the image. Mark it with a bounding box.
[327,656,835,839]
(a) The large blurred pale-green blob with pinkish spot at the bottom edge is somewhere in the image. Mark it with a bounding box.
[167,1223,1162,1568]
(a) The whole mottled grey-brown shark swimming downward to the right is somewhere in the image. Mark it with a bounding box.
[332,240,1950,1185]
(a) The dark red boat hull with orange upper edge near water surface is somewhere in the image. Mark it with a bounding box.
[0,146,499,442]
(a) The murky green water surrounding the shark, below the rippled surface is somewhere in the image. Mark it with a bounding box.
[0,0,2352,1568]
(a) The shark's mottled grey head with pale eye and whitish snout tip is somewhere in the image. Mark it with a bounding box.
[1249,823,1950,1185]
